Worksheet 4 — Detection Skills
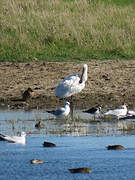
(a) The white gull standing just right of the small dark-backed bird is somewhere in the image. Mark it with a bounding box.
[103,104,128,119]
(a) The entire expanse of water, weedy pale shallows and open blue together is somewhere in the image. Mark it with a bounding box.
[0,110,135,180]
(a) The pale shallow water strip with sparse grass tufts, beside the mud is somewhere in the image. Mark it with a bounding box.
[0,109,135,136]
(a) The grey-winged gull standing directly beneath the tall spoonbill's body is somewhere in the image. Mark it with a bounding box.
[47,102,70,119]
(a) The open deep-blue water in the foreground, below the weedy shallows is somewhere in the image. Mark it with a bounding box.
[0,135,135,180]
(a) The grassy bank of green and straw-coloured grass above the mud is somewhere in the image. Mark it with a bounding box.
[0,0,135,61]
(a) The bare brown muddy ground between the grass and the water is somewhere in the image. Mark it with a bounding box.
[0,60,135,109]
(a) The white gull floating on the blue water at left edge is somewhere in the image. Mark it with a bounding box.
[0,132,26,144]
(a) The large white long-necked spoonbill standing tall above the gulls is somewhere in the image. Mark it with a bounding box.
[55,64,88,119]
